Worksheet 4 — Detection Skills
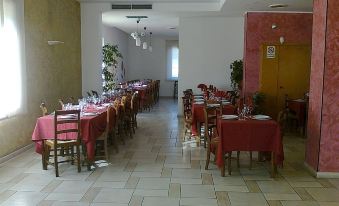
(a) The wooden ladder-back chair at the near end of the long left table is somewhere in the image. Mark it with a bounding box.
[42,110,81,177]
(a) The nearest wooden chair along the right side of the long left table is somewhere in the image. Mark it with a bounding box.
[95,106,115,161]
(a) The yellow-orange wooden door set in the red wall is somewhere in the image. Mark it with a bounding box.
[260,45,311,118]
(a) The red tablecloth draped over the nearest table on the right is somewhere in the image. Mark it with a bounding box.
[217,119,284,167]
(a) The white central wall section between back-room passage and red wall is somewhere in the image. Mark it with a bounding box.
[178,17,244,114]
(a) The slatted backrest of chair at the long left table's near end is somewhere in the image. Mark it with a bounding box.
[54,110,81,142]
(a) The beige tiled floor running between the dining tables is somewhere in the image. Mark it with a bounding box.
[0,99,339,206]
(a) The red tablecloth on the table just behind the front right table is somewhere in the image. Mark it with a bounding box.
[192,103,235,135]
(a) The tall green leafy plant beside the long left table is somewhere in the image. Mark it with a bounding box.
[102,44,123,92]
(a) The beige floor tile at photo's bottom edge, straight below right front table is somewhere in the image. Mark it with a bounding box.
[228,192,268,206]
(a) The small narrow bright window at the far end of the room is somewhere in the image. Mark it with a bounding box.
[166,41,179,80]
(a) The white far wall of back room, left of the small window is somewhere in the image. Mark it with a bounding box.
[126,37,174,96]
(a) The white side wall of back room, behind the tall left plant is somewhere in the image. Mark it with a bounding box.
[102,25,129,82]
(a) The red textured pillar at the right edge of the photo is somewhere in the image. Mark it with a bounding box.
[306,0,339,174]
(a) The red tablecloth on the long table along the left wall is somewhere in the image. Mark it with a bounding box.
[32,109,115,161]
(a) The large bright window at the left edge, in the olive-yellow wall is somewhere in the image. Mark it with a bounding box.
[0,0,24,119]
